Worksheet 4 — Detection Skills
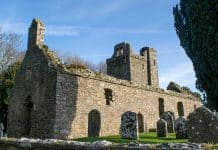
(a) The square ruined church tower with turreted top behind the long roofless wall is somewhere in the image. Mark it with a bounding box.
[107,42,159,87]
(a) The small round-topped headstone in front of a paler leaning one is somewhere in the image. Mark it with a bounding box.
[157,119,167,137]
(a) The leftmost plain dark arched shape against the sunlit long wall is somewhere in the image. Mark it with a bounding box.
[88,109,101,137]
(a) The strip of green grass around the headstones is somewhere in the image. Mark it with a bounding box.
[74,132,188,143]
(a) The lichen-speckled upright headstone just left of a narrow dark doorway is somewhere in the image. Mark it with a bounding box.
[121,111,138,140]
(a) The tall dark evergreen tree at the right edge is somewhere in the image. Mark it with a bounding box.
[173,0,218,111]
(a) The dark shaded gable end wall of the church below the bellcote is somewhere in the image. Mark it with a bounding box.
[8,46,57,138]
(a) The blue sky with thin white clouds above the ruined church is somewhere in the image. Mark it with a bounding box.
[0,0,196,90]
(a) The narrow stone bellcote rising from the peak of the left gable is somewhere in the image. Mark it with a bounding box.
[27,19,45,50]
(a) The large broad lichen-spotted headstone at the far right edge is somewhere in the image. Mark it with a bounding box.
[187,107,218,143]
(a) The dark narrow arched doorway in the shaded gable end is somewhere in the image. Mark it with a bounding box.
[23,96,33,137]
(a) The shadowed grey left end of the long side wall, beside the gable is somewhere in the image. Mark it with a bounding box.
[54,71,78,138]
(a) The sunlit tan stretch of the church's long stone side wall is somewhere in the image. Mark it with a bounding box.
[58,72,201,138]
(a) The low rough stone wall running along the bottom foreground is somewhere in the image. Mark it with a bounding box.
[0,138,204,150]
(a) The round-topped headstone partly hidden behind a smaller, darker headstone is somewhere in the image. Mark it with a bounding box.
[160,111,175,133]
